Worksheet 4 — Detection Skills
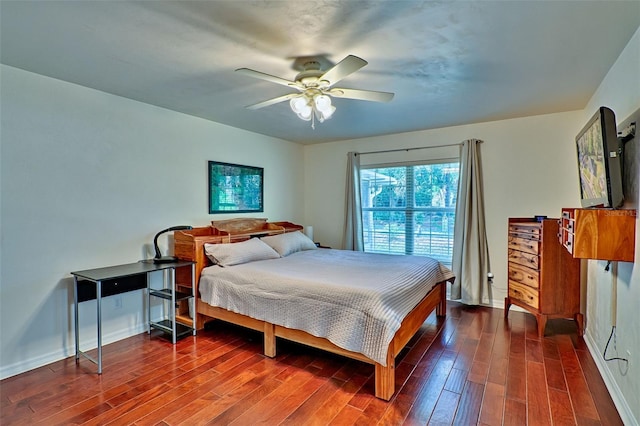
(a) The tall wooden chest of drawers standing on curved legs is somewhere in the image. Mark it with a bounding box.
[504,218,584,337]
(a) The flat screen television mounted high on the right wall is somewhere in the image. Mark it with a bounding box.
[576,107,624,208]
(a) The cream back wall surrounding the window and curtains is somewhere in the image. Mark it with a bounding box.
[305,111,582,307]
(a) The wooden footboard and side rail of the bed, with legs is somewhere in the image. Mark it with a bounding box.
[192,282,447,401]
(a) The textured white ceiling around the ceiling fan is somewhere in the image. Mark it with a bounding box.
[0,0,640,144]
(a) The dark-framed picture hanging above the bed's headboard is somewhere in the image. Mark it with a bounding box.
[209,161,264,214]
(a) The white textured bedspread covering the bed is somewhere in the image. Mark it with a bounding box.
[199,249,453,365]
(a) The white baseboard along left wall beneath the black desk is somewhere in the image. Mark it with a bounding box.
[0,324,147,380]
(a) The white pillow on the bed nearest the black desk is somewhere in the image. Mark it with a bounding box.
[204,238,280,266]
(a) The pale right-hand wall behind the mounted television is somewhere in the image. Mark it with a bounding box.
[582,29,640,424]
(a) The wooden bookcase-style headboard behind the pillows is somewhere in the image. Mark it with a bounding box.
[173,218,303,306]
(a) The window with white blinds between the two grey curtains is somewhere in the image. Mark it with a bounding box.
[360,160,460,266]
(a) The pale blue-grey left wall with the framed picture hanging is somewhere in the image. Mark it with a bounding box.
[0,66,303,378]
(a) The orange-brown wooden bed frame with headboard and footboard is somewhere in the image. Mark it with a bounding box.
[174,219,446,401]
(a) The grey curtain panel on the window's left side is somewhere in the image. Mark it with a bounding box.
[342,152,364,251]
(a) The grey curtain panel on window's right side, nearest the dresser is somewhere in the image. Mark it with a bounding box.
[451,139,492,305]
